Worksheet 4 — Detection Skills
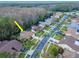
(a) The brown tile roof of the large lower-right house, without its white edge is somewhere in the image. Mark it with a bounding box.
[59,36,79,51]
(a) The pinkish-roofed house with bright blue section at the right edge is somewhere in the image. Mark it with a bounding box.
[65,22,79,38]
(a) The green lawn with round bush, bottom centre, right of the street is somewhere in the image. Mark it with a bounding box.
[42,43,59,58]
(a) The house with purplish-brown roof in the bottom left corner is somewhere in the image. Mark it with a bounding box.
[0,40,22,52]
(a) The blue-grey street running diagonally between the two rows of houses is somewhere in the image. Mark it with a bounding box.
[31,15,68,58]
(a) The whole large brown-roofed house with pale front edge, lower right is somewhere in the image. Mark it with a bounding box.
[58,36,79,54]
